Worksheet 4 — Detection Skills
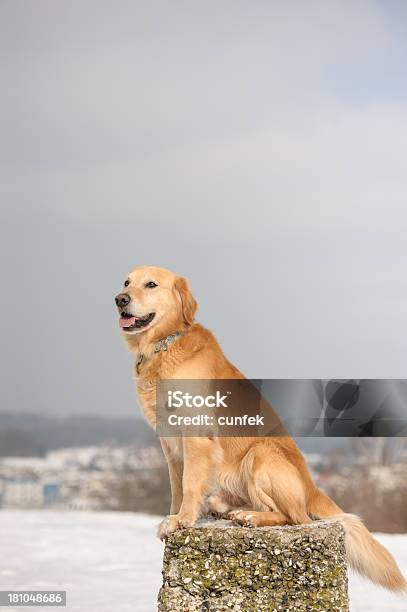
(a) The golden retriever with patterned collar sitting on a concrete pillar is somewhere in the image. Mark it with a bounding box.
[115,266,407,591]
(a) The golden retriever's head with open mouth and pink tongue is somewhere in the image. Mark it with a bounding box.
[115,266,198,335]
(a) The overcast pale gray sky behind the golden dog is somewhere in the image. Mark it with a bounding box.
[0,0,407,416]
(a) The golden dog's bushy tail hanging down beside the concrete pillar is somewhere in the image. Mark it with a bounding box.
[309,489,407,593]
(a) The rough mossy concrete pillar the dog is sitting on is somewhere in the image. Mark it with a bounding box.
[158,520,349,612]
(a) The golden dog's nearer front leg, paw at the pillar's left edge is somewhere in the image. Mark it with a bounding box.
[158,438,219,539]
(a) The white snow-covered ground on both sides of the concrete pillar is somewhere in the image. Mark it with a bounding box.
[0,510,407,612]
